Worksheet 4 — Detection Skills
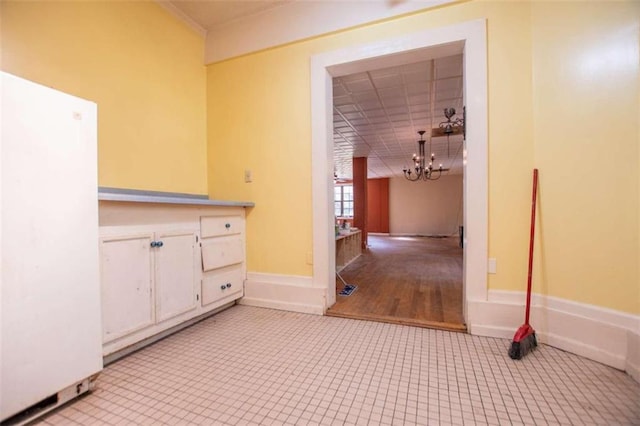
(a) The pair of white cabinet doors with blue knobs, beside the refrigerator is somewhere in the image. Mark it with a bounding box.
[100,230,199,342]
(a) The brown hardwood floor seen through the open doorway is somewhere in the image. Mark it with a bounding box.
[327,235,466,331]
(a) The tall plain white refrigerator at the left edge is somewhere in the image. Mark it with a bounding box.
[0,73,102,422]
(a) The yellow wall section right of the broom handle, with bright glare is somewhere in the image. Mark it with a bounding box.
[532,2,640,313]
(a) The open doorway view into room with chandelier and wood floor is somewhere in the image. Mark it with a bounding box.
[327,54,465,330]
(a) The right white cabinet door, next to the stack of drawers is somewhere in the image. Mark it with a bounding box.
[153,231,198,322]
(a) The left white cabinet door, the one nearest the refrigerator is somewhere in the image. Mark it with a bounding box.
[100,233,154,342]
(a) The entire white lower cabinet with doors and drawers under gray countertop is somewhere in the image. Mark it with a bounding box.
[100,201,246,359]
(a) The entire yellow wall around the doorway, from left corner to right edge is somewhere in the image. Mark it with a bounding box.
[207,1,640,314]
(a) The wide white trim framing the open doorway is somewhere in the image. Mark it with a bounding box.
[311,19,488,324]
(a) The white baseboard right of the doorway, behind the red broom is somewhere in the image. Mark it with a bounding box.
[467,290,640,381]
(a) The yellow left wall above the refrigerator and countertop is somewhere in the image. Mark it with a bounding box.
[0,0,207,194]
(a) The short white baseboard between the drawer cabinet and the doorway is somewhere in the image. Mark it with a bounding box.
[238,272,327,315]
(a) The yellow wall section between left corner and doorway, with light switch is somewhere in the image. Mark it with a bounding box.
[208,46,312,275]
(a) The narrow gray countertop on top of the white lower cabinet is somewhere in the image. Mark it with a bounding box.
[98,187,255,207]
